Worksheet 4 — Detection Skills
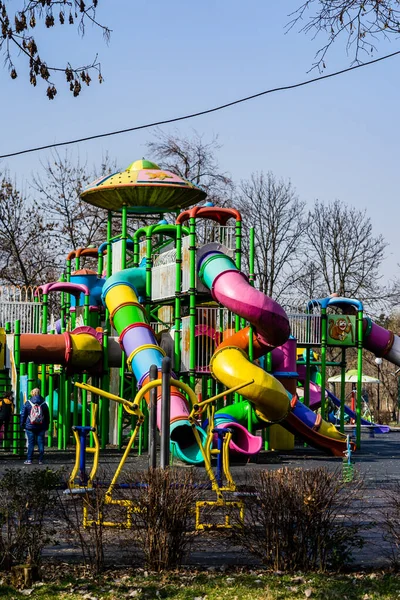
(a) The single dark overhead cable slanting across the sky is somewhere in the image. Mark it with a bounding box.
[0,50,400,159]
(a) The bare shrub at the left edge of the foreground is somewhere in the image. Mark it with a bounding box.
[0,469,60,571]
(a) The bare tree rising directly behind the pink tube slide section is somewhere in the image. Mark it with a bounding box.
[236,172,307,299]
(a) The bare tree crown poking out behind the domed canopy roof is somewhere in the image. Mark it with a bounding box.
[147,129,232,206]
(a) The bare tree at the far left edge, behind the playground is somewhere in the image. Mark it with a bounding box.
[0,175,57,286]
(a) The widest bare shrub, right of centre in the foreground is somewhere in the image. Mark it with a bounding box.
[228,468,363,571]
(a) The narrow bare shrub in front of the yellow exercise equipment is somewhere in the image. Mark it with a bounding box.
[123,469,202,571]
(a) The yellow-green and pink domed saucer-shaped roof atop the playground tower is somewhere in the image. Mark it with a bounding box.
[81,160,207,214]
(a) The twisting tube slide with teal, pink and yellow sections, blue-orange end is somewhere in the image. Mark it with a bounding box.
[199,247,347,456]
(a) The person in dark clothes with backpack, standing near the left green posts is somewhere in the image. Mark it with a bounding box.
[21,388,50,465]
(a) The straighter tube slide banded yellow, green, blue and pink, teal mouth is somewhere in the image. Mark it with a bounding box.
[102,268,207,464]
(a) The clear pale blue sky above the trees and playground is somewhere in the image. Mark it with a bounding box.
[0,0,400,286]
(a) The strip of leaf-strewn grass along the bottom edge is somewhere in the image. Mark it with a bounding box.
[0,569,400,600]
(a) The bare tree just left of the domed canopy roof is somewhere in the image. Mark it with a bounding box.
[32,152,115,254]
